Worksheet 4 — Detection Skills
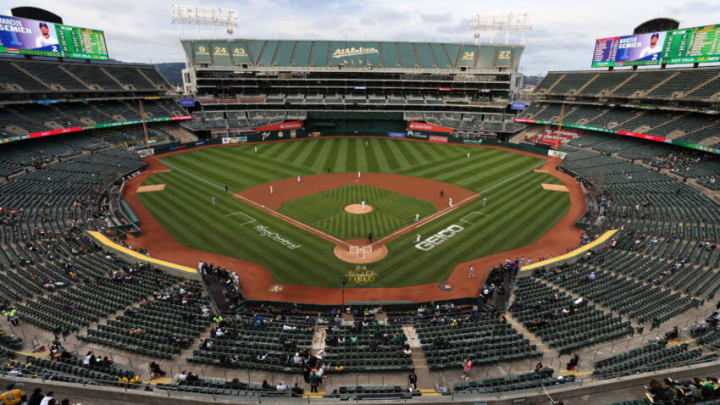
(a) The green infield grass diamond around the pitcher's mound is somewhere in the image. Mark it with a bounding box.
[279,185,436,240]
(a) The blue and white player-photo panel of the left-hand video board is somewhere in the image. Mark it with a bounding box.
[0,16,61,56]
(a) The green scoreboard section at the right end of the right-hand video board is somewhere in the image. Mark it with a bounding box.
[662,25,720,64]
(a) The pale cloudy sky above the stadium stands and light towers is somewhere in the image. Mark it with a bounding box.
[5,0,720,75]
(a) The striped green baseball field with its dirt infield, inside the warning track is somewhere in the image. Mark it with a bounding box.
[137,137,570,288]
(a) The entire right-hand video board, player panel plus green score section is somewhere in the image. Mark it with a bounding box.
[592,25,720,67]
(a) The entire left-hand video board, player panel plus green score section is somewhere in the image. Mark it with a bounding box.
[0,15,108,60]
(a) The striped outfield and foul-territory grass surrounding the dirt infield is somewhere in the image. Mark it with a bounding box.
[139,138,570,288]
